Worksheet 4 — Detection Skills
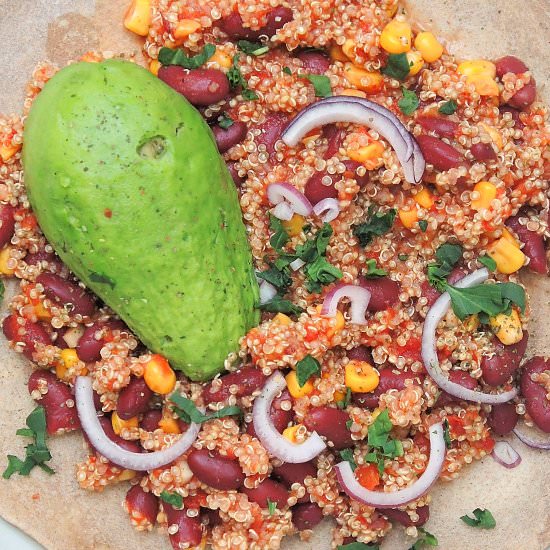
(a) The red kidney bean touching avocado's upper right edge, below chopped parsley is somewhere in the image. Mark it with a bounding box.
[158,65,230,106]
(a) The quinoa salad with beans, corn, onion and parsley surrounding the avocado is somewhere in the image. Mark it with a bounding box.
[0,0,550,550]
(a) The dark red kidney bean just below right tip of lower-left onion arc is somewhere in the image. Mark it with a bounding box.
[187,449,244,491]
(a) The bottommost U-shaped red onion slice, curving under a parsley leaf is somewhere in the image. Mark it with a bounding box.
[335,423,446,508]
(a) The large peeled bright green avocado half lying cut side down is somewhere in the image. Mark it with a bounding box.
[23,60,259,381]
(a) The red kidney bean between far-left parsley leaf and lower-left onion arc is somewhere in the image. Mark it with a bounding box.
[27,370,80,435]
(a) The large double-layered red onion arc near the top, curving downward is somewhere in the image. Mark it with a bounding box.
[281,96,426,183]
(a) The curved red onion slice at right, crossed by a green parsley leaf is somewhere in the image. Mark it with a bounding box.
[422,268,518,404]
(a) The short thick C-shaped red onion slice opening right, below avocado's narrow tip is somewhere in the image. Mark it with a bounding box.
[252,371,326,464]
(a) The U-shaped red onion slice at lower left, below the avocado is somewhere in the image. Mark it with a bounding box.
[75,376,200,472]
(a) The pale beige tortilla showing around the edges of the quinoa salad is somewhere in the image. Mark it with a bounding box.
[0,0,550,550]
